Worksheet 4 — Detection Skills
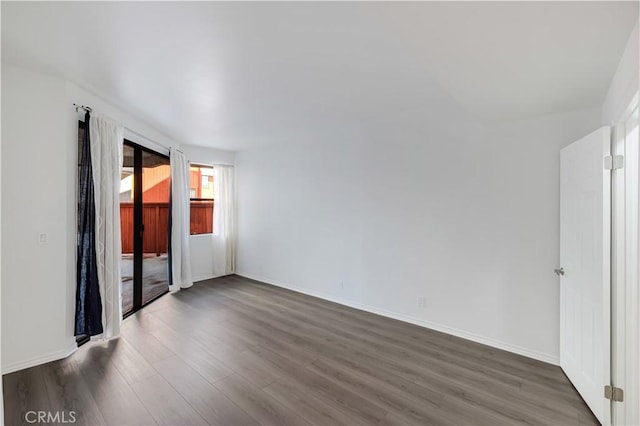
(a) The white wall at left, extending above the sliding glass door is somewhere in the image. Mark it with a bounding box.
[1,63,233,373]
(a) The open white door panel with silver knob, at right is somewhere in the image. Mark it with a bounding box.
[560,127,611,425]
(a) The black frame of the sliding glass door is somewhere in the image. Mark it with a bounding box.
[122,138,171,319]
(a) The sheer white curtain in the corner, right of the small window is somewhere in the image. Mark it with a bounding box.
[213,166,236,276]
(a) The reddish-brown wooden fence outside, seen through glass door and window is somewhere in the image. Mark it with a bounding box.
[120,201,213,256]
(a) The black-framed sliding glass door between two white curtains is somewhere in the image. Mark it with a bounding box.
[120,141,171,315]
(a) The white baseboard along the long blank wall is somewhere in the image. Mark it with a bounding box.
[236,272,560,365]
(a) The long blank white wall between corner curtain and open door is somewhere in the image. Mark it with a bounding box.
[237,99,600,363]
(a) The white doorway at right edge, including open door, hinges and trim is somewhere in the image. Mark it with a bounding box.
[556,107,640,425]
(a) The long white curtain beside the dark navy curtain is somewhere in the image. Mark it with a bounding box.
[89,112,124,339]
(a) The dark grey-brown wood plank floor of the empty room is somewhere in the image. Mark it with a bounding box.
[3,276,598,426]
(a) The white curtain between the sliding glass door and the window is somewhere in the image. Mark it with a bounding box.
[169,149,193,292]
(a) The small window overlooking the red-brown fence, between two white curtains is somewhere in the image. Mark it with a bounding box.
[189,164,213,235]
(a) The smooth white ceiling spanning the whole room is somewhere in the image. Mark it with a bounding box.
[2,1,638,149]
